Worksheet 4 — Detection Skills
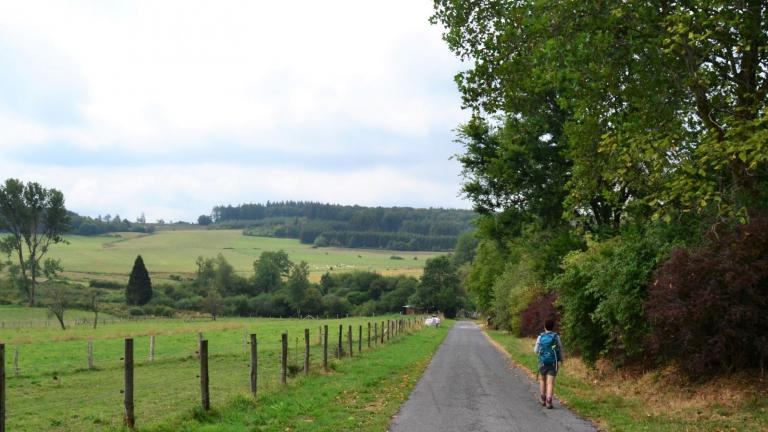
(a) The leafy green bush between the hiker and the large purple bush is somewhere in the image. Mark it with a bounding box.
[551,229,669,363]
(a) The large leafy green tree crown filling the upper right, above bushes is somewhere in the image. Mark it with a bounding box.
[433,0,768,228]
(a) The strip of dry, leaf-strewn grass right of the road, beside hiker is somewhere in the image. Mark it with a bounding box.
[487,330,768,432]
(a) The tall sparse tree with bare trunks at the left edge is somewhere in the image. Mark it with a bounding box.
[0,178,69,306]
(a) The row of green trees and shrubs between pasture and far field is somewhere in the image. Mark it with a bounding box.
[138,250,468,317]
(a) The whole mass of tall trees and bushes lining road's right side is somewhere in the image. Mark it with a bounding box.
[432,0,768,374]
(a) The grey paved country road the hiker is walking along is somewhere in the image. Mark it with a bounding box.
[389,321,596,432]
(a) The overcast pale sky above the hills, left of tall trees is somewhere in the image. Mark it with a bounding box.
[0,0,469,221]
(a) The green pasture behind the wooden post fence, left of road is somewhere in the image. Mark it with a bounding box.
[0,316,426,431]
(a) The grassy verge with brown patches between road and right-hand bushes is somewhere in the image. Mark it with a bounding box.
[487,330,768,432]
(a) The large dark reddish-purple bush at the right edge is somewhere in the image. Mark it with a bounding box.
[647,214,768,376]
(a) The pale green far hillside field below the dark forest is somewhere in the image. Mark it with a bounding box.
[45,229,438,281]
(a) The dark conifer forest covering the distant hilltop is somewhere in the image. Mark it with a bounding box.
[207,201,476,251]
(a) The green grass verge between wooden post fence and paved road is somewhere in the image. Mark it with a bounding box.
[141,323,452,432]
